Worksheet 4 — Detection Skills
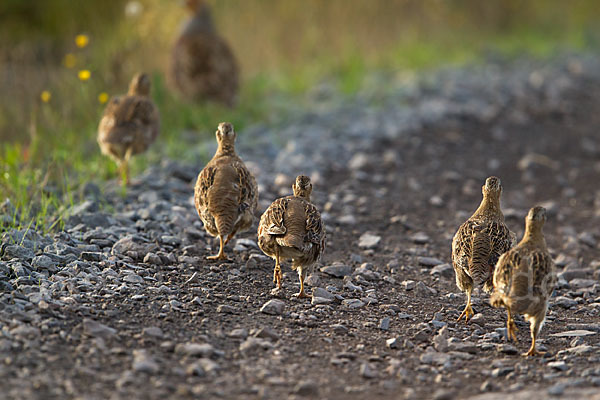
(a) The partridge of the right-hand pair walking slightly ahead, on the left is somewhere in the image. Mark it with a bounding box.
[452,176,516,322]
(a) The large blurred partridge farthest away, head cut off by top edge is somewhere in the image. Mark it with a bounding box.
[167,0,239,107]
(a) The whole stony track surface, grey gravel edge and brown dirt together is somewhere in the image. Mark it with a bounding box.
[0,55,600,400]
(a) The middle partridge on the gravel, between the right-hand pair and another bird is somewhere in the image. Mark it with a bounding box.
[258,175,325,297]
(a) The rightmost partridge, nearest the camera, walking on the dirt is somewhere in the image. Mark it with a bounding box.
[490,207,557,356]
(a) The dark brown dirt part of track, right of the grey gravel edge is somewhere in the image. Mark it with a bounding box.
[0,69,600,399]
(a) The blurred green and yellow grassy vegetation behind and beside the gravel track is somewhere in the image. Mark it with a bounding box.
[0,0,600,229]
